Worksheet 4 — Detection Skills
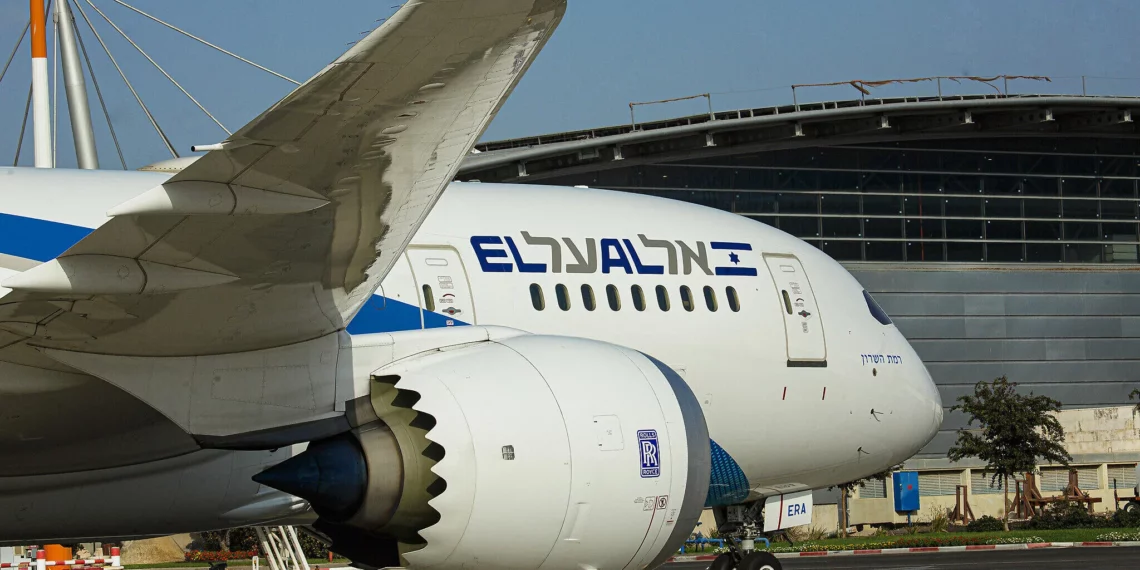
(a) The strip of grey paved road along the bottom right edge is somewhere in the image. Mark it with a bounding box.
[662,547,1140,570]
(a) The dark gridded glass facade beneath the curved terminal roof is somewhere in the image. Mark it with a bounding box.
[544,138,1140,263]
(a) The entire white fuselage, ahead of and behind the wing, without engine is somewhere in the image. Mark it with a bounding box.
[0,169,942,542]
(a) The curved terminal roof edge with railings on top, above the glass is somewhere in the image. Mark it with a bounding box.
[458,95,1140,181]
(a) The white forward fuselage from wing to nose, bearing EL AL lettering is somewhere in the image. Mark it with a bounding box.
[385,184,942,496]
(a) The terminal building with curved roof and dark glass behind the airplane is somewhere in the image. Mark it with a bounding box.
[458,96,1140,522]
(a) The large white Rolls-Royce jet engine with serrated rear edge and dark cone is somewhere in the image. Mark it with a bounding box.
[257,335,709,569]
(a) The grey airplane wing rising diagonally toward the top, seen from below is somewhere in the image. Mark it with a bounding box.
[0,0,565,356]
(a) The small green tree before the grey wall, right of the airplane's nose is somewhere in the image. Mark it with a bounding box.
[948,376,1073,530]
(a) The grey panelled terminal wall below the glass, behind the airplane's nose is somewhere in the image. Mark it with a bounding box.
[846,262,1140,467]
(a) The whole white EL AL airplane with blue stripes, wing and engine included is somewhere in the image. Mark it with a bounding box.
[0,0,942,570]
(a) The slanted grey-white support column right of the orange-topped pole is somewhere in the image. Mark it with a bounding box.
[56,0,99,170]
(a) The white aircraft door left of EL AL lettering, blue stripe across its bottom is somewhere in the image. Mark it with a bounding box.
[407,246,475,328]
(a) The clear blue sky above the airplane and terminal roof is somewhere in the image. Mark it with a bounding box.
[0,0,1140,168]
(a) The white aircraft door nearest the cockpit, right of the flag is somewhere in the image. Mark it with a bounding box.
[764,254,828,367]
